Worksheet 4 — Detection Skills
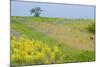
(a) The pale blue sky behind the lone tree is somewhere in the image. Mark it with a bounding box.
[11,1,95,19]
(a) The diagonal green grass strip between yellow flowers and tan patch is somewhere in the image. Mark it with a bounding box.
[12,23,61,46]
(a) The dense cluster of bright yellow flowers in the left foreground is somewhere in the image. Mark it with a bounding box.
[11,37,64,64]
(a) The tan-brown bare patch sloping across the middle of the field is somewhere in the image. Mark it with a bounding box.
[28,22,94,50]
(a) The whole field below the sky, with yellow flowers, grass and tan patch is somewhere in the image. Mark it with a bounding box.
[11,16,95,65]
